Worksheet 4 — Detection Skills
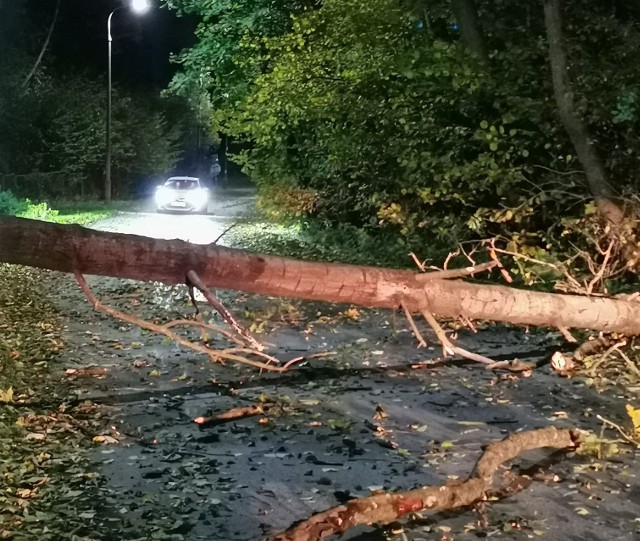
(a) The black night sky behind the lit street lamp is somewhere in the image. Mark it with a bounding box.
[38,0,195,90]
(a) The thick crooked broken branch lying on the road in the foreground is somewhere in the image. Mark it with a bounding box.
[268,427,581,541]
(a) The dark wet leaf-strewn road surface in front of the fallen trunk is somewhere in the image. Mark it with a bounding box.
[45,187,640,541]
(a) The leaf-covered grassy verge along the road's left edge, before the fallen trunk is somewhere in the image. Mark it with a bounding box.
[0,265,108,541]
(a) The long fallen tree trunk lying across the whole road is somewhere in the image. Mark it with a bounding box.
[0,217,640,335]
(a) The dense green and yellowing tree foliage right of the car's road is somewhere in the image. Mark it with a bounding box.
[168,0,640,274]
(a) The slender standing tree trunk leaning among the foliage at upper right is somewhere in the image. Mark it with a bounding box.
[544,0,624,226]
